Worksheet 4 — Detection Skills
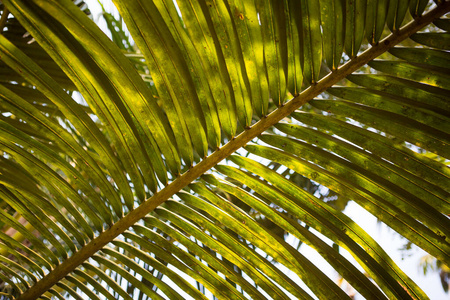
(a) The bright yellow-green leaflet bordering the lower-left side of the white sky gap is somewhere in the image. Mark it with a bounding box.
[223,156,423,299]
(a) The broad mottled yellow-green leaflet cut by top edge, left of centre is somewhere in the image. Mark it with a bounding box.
[116,1,207,165]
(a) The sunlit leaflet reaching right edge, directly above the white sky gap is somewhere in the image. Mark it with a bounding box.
[261,135,449,240]
